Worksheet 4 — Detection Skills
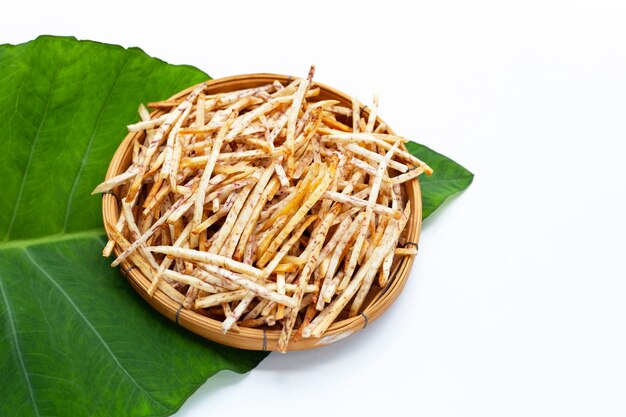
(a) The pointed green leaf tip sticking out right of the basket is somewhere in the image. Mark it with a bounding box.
[406,142,474,219]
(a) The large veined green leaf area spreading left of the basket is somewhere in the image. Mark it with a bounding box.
[0,36,266,416]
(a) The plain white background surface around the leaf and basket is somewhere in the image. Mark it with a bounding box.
[0,0,626,417]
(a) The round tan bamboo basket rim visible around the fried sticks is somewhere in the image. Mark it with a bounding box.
[102,73,422,351]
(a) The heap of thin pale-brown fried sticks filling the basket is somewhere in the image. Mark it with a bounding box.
[94,68,432,352]
